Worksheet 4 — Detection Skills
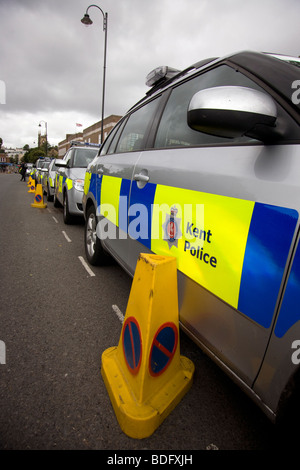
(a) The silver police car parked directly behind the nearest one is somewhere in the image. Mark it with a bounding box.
[54,142,99,224]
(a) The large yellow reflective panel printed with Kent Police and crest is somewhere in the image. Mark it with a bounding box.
[151,185,254,308]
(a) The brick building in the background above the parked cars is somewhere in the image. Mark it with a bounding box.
[58,114,122,158]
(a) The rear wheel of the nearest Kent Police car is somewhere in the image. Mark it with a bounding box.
[84,206,109,266]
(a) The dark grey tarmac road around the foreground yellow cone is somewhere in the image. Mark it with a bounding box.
[0,174,291,453]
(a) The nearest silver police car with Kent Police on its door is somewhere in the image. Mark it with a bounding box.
[83,51,300,421]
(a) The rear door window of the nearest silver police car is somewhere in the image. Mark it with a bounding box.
[116,99,158,153]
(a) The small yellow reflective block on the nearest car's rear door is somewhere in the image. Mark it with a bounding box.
[100,175,122,226]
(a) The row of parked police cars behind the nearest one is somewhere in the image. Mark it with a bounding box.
[31,142,100,224]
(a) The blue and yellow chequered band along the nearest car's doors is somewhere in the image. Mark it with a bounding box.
[85,175,300,334]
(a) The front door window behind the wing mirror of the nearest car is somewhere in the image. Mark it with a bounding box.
[154,65,288,148]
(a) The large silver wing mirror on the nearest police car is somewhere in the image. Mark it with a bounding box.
[187,86,277,142]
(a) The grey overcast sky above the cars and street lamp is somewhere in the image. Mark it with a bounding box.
[0,0,300,147]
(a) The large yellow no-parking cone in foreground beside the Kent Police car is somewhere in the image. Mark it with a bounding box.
[101,254,194,439]
